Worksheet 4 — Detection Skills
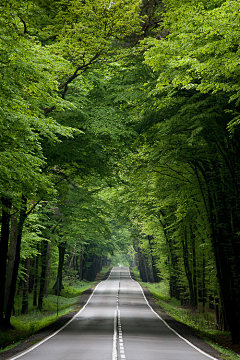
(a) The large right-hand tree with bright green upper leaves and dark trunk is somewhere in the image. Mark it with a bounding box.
[136,1,240,342]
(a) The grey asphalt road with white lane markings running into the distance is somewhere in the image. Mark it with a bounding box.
[8,267,219,360]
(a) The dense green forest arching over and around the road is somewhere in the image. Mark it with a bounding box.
[0,0,240,344]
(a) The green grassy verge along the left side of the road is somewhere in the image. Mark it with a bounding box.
[0,267,109,353]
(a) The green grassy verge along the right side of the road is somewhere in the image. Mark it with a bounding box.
[141,281,240,360]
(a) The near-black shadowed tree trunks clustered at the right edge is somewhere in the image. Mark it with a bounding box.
[195,154,240,343]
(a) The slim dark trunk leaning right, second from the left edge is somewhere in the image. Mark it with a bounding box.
[4,195,27,327]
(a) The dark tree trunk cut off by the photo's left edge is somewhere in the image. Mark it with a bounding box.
[0,197,12,326]
